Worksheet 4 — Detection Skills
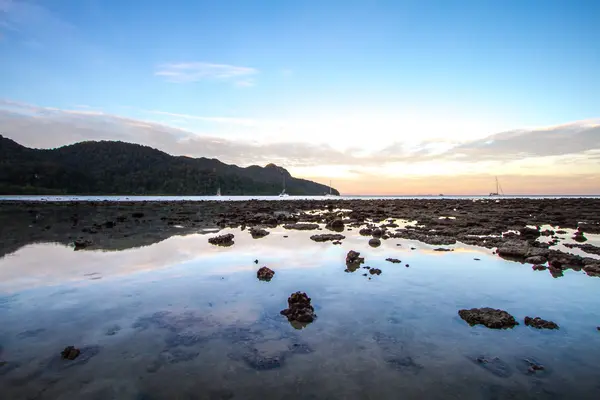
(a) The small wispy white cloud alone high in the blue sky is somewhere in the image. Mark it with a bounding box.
[154,62,258,87]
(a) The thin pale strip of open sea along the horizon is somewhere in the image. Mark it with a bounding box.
[0,195,600,201]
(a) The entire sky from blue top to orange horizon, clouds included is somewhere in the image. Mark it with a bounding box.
[0,0,600,195]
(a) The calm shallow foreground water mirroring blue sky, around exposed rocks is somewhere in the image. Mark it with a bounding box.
[0,229,600,399]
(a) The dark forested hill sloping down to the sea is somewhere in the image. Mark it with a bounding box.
[0,136,338,196]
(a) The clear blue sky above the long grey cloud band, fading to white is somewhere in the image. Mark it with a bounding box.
[0,0,600,194]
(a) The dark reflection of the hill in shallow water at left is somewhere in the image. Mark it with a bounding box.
[0,203,217,257]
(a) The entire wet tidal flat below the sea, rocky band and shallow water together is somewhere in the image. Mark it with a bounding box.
[0,199,600,399]
